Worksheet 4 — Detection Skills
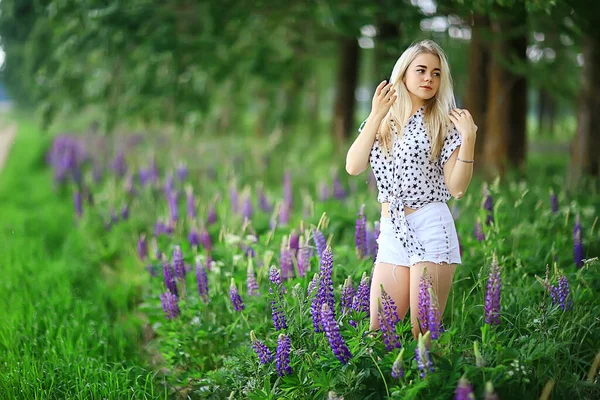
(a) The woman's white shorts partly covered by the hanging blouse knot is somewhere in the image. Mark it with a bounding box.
[375,202,462,267]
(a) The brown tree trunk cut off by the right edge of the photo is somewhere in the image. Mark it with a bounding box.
[567,37,600,190]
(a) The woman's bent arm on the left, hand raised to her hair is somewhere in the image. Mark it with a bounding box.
[346,81,397,175]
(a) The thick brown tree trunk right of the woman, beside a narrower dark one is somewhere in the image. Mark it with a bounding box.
[481,11,527,177]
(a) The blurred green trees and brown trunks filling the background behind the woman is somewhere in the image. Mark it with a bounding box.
[0,0,600,185]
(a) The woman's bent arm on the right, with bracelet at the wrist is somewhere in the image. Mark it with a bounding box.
[444,108,477,199]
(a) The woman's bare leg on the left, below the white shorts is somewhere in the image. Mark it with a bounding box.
[370,262,410,330]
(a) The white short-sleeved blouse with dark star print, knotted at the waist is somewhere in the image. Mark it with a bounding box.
[358,107,462,257]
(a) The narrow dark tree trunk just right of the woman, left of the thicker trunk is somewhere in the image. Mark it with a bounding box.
[465,14,490,173]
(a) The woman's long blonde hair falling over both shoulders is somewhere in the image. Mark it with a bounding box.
[378,40,456,160]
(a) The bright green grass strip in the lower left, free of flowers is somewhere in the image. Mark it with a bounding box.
[0,120,166,399]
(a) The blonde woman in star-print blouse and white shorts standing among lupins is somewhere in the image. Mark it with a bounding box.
[346,40,477,338]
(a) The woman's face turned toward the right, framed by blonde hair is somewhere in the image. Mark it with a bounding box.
[402,53,442,104]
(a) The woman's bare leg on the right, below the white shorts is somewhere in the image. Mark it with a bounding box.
[410,262,456,339]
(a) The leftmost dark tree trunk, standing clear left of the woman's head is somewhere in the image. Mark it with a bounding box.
[333,37,359,143]
